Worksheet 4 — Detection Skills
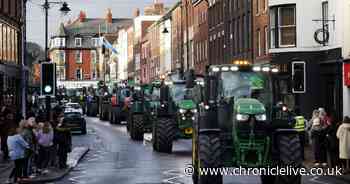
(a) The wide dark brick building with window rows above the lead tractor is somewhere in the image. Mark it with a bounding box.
[208,0,253,64]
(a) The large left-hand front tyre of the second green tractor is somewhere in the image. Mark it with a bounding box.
[153,118,176,153]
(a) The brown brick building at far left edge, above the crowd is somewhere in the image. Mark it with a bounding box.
[0,0,25,109]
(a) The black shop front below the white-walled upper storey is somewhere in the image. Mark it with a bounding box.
[271,48,342,121]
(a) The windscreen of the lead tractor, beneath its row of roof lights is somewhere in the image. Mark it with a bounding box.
[221,72,272,116]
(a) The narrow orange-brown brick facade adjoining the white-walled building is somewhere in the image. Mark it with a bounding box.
[252,0,270,63]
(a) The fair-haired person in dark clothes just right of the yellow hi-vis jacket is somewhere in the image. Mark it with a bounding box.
[310,110,327,167]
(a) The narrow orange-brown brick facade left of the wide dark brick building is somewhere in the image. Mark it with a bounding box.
[193,0,209,74]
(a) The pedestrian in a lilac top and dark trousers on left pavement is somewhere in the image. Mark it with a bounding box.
[37,122,53,173]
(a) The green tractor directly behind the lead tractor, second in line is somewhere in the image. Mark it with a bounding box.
[151,79,197,153]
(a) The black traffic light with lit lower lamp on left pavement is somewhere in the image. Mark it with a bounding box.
[40,63,56,96]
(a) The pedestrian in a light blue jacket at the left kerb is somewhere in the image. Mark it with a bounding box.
[7,128,30,183]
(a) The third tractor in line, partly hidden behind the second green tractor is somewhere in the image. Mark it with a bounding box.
[127,83,154,140]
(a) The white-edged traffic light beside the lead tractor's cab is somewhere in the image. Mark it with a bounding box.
[292,61,306,93]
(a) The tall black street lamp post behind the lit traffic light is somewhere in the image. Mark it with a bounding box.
[42,0,71,120]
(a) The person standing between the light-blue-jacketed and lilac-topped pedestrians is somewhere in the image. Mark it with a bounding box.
[20,117,37,177]
